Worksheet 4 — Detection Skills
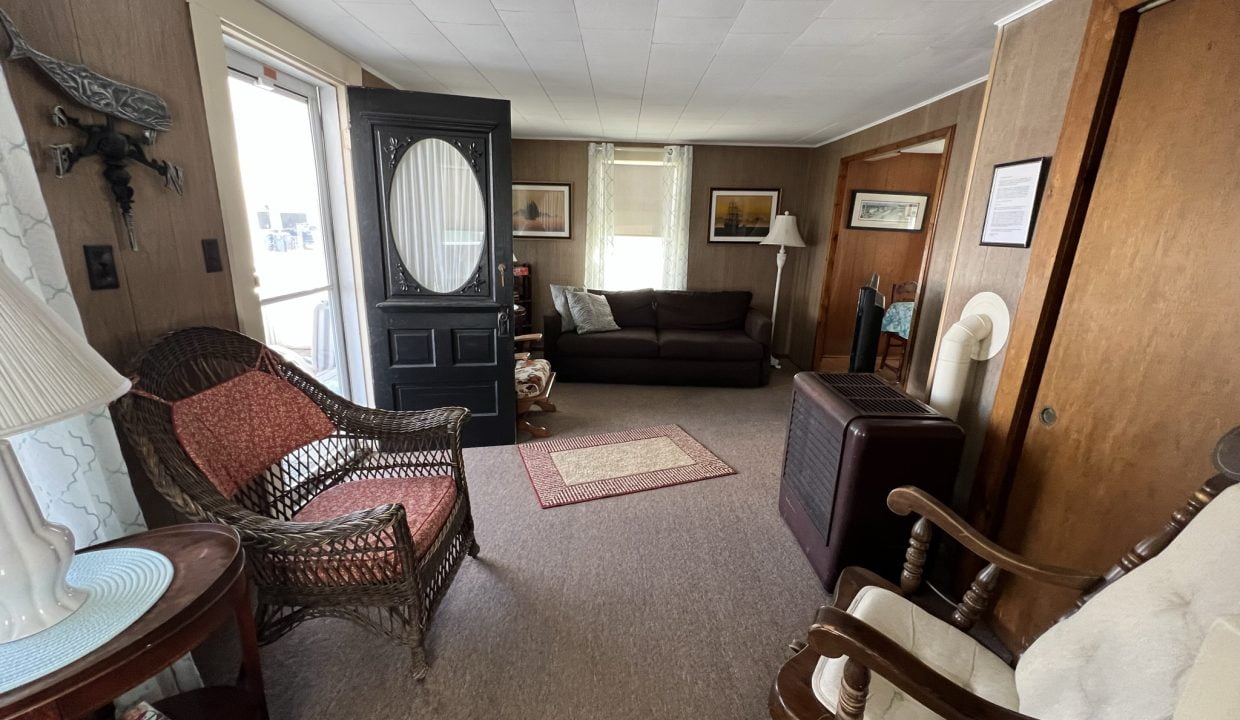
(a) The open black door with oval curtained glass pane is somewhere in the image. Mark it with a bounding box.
[348,88,516,445]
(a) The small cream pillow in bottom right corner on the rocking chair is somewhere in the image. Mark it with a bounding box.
[1174,615,1240,720]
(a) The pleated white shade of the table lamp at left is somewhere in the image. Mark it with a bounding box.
[0,265,129,437]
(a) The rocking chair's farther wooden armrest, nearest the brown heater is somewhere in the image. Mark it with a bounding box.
[887,486,1102,591]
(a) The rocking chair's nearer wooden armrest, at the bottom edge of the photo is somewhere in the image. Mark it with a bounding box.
[808,605,1037,720]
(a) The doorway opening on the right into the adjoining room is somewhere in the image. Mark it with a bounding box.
[813,126,955,385]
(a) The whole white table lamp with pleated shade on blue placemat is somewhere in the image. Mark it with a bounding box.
[0,265,129,642]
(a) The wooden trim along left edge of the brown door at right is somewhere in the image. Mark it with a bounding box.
[968,0,1151,535]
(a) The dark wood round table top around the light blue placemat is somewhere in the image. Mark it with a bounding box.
[0,523,244,718]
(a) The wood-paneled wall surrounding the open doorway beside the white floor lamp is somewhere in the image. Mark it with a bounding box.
[781,84,985,394]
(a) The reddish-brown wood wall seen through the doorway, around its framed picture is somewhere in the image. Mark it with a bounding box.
[815,154,942,359]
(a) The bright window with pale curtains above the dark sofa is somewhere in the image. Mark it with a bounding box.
[585,144,693,290]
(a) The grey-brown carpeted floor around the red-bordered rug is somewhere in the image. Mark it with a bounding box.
[263,369,826,720]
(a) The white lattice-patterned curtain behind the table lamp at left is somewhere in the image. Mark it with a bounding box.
[0,68,201,696]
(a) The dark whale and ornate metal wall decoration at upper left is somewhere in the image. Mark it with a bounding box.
[0,10,185,250]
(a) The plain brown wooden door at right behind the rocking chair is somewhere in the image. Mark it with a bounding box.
[997,0,1240,642]
